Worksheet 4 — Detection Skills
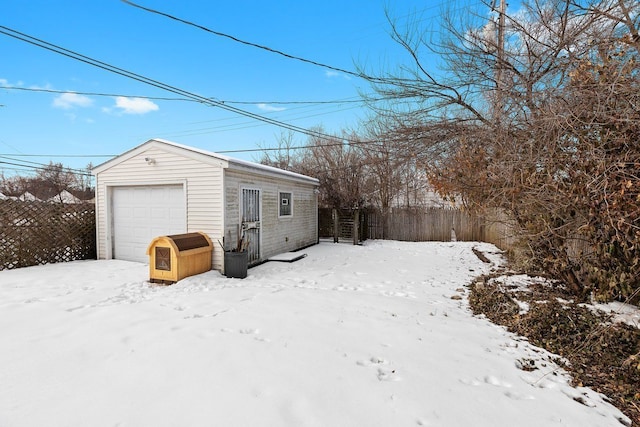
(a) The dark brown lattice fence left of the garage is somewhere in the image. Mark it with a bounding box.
[0,200,96,270]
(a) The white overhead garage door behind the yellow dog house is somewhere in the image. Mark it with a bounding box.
[111,185,187,263]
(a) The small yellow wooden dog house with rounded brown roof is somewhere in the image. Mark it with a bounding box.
[147,232,213,284]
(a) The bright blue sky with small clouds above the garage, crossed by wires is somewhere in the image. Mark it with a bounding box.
[0,0,478,175]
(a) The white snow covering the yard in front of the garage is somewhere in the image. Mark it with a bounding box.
[0,241,628,427]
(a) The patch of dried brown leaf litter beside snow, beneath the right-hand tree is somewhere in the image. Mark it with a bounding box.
[469,281,640,426]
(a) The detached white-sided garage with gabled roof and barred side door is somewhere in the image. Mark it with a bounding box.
[93,139,318,272]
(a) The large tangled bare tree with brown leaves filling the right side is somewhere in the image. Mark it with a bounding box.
[364,0,640,297]
